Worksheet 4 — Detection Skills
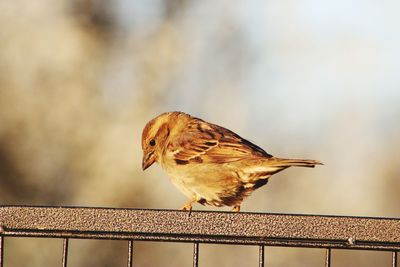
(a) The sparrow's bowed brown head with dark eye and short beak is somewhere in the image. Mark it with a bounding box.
[142,112,183,170]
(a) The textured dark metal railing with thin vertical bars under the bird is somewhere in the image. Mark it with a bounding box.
[0,206,400,267]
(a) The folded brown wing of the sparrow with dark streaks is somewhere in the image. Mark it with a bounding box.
[173,118,272,164]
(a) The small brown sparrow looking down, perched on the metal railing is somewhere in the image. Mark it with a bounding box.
[141,111,323,212]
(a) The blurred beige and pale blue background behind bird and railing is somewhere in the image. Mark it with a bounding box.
[0,0,400,267]
